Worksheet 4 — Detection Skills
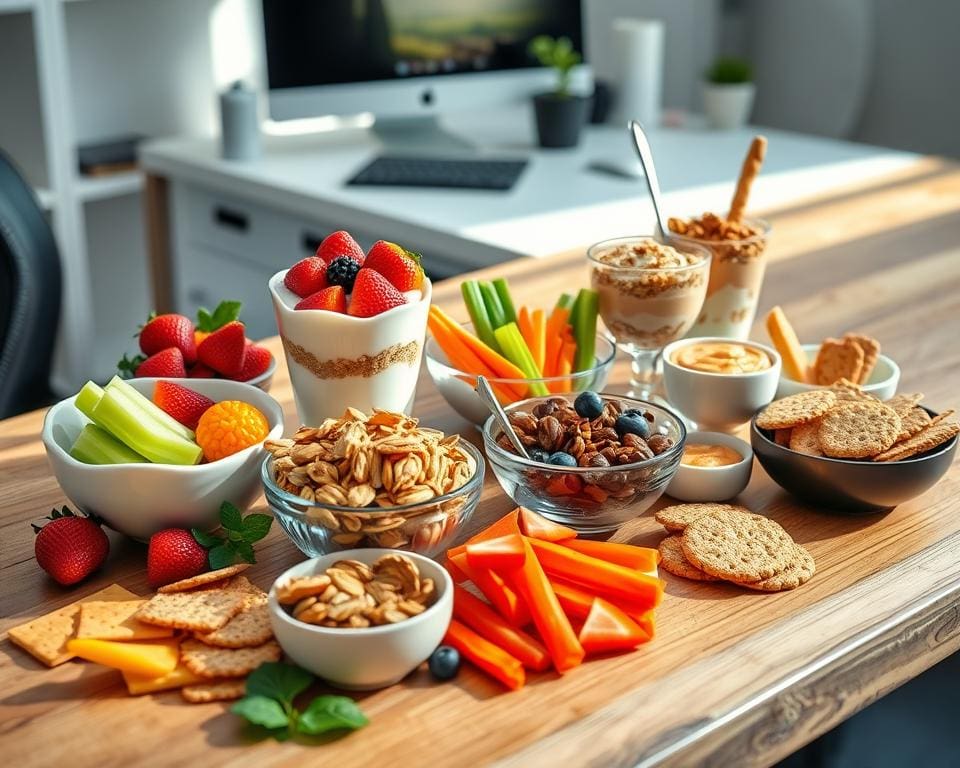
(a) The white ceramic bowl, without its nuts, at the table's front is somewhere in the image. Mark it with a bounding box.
[269,549,453,691]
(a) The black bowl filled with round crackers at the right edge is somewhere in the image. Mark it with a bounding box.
[750,382,960,514]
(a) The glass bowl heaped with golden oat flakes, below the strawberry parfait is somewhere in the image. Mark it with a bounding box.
[262,408,485,557]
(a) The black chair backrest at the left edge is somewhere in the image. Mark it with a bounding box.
[0,151,61,419]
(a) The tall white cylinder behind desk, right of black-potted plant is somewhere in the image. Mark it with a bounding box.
[612,19,664,127]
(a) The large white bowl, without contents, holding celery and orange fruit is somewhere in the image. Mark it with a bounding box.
[42,378,283,539]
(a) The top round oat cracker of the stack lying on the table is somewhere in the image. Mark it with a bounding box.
[680,512,794,583]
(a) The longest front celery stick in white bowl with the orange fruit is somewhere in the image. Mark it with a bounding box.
[93,387,203,464]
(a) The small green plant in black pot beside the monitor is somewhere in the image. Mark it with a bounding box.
[529,35,590,147]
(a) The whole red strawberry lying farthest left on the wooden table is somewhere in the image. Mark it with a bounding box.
[33,507,110,587]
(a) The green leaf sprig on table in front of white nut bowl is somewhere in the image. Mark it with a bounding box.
[230,661,370,740]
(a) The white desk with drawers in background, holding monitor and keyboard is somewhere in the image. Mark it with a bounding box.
[141,111,916,335]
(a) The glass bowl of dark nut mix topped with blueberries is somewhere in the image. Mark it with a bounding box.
[483,392,687,534]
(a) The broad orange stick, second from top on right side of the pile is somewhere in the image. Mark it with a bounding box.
[526,539,663,611]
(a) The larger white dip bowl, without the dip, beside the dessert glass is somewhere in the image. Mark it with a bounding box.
[663,336,781,432]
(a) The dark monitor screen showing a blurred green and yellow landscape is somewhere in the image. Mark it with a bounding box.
[263,0,582,90]
